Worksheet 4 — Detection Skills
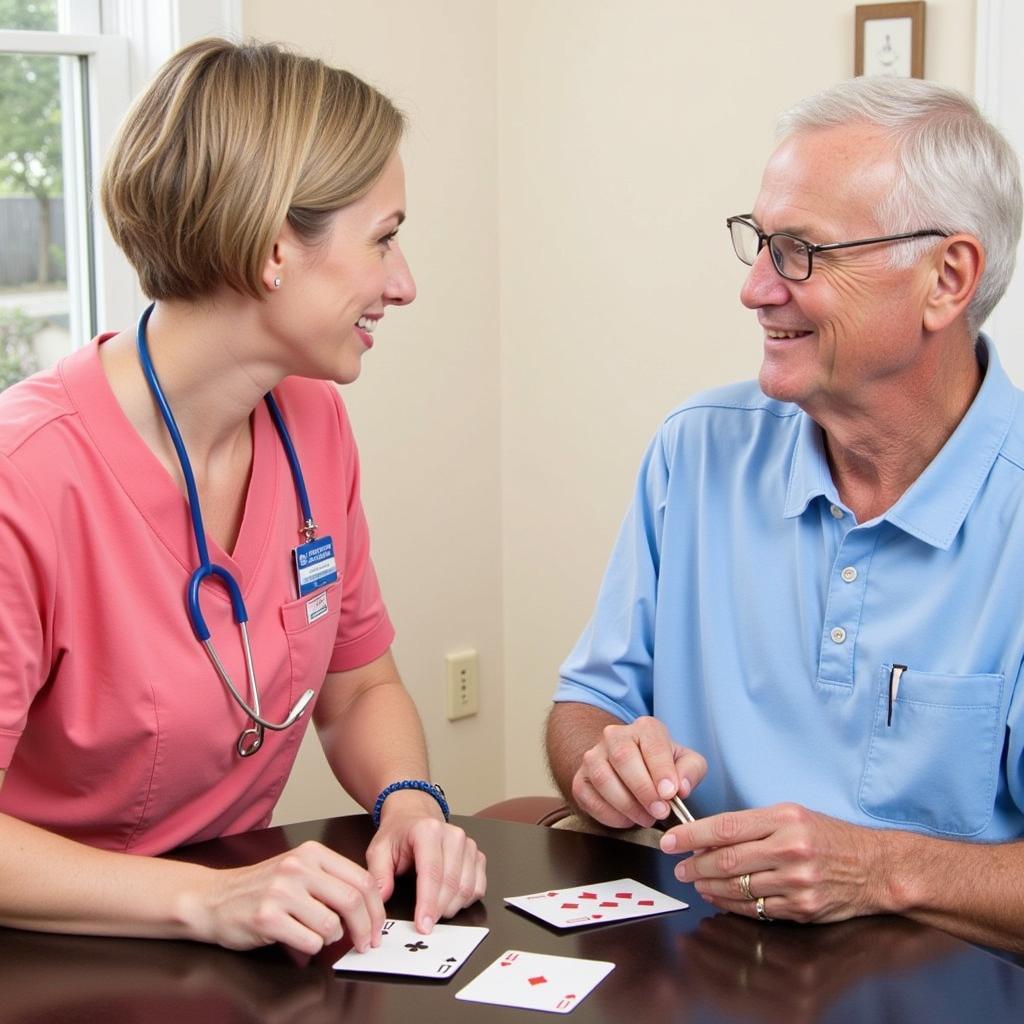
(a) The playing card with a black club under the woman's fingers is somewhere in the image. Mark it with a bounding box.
[334,920,487,978]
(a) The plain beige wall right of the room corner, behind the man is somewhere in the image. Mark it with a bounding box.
[498,0,974,793]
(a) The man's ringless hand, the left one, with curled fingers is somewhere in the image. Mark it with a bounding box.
[572,717,708,828]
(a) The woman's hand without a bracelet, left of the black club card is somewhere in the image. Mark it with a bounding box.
[183,842,385,955]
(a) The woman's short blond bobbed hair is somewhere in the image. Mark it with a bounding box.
[100,39,404,299]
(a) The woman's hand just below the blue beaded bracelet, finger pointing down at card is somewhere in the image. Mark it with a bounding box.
[367,792,487,933]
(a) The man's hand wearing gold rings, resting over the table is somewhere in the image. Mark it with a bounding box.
[662,804,900,923]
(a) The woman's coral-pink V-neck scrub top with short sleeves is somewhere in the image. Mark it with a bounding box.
[0,335,394,854]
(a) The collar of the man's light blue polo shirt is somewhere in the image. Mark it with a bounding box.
[783,334,1019,550]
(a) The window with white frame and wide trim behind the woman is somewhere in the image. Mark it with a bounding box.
[0,0,241,390]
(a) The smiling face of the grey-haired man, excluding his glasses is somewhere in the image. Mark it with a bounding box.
[740,125,929,416]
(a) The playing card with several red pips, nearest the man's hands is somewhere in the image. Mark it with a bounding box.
[505,879,689,928]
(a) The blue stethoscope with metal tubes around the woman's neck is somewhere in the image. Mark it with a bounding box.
[135,303,316,758]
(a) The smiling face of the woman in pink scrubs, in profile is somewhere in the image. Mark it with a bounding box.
[265,155,416,384]
